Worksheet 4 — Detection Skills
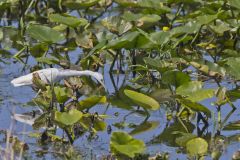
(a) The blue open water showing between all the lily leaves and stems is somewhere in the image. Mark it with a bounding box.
[0,1,240,160]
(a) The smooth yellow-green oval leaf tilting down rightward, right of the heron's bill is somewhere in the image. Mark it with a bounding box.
[124,89,160,110]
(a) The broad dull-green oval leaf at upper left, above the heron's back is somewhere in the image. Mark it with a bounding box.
[27,24,65,43]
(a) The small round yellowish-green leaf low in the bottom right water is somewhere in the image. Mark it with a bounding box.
[186,138,208,156]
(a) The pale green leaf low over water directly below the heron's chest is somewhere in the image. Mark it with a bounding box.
[55,109,83,125]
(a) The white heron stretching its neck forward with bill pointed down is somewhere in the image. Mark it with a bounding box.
[11,68,105,88]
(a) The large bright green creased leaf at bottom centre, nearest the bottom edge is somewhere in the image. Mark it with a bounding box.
[110,132,145,158]
